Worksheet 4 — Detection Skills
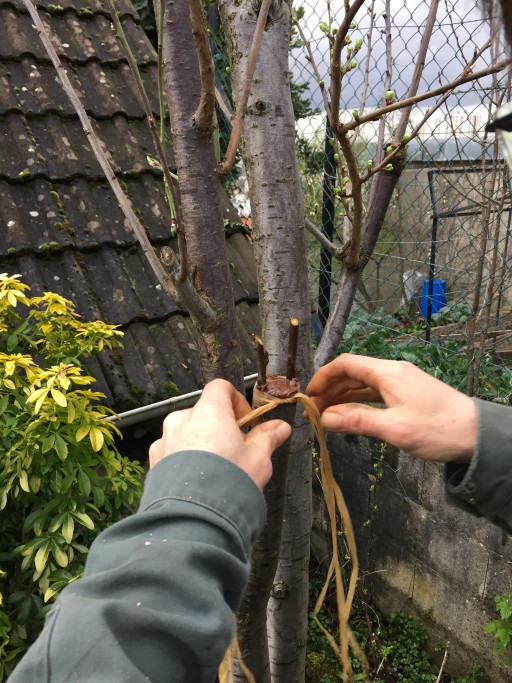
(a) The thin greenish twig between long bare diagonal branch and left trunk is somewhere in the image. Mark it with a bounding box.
[108,0,187,282]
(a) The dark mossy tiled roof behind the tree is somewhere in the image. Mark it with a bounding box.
[0,0,259,410]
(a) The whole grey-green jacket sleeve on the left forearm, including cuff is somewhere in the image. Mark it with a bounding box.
[10,451,265,683]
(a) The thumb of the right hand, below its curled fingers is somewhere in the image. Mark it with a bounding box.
[322,403,389,440]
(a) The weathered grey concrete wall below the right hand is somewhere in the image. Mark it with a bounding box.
[322,435,512,683]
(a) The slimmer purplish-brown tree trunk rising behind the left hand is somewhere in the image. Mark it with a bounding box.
[162,0,243,389]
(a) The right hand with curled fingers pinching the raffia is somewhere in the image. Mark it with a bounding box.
[306,353,477,462]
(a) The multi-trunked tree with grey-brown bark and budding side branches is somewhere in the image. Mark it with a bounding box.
[26,0,505,683]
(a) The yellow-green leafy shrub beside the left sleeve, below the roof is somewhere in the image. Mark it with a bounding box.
[0,273,142,681]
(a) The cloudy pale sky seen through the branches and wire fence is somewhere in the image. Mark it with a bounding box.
[290,0,506,117]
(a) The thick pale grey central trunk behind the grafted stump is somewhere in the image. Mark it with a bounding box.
[220,0,312,683]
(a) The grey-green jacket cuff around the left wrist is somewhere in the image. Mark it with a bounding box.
[139,450,266,551]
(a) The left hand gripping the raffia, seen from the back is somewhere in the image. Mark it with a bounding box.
[149,379,292,489]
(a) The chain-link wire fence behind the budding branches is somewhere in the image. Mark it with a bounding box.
[291,0,512,401]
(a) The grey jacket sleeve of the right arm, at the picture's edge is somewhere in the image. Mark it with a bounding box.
[446,400,512,533]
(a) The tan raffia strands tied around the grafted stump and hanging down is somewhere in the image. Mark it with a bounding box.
[219,377,368,683]
